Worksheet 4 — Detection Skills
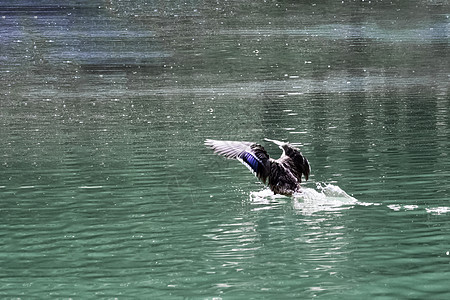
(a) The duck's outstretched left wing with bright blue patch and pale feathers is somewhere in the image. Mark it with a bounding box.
[205,139,270,183]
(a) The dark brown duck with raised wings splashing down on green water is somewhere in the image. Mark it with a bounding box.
[204,138,311,196]
